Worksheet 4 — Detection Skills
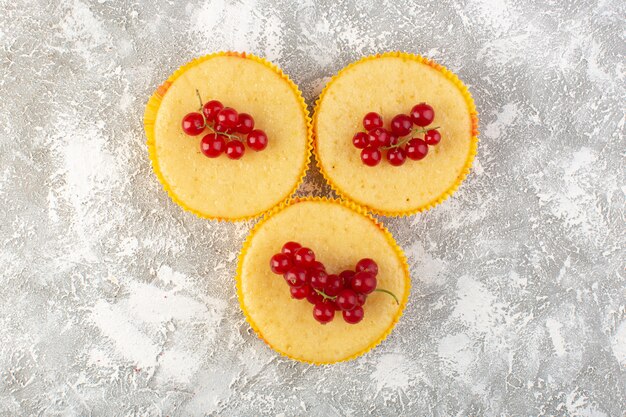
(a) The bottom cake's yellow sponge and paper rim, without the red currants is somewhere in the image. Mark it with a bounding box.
[237,198,410,364]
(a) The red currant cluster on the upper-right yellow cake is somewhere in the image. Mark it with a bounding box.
[352,103,441,167]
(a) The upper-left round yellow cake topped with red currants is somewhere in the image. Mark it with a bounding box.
[144,52,311,220]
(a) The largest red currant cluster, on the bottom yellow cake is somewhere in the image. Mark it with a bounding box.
[270,242,399,324]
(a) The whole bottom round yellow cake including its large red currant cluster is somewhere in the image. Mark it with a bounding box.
[237,198,410,364]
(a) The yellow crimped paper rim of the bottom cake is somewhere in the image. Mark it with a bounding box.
[236,197,411,365]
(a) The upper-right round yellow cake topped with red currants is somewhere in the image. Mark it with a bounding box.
[313,52,478,216]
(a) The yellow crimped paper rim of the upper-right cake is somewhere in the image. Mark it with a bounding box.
[313,51,479,217]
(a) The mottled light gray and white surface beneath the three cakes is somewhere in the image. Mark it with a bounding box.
[0,0,626,416]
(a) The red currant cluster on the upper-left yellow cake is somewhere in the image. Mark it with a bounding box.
[182,93,267,159]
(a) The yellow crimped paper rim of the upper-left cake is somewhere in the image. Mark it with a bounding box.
[143,51,313,221]
